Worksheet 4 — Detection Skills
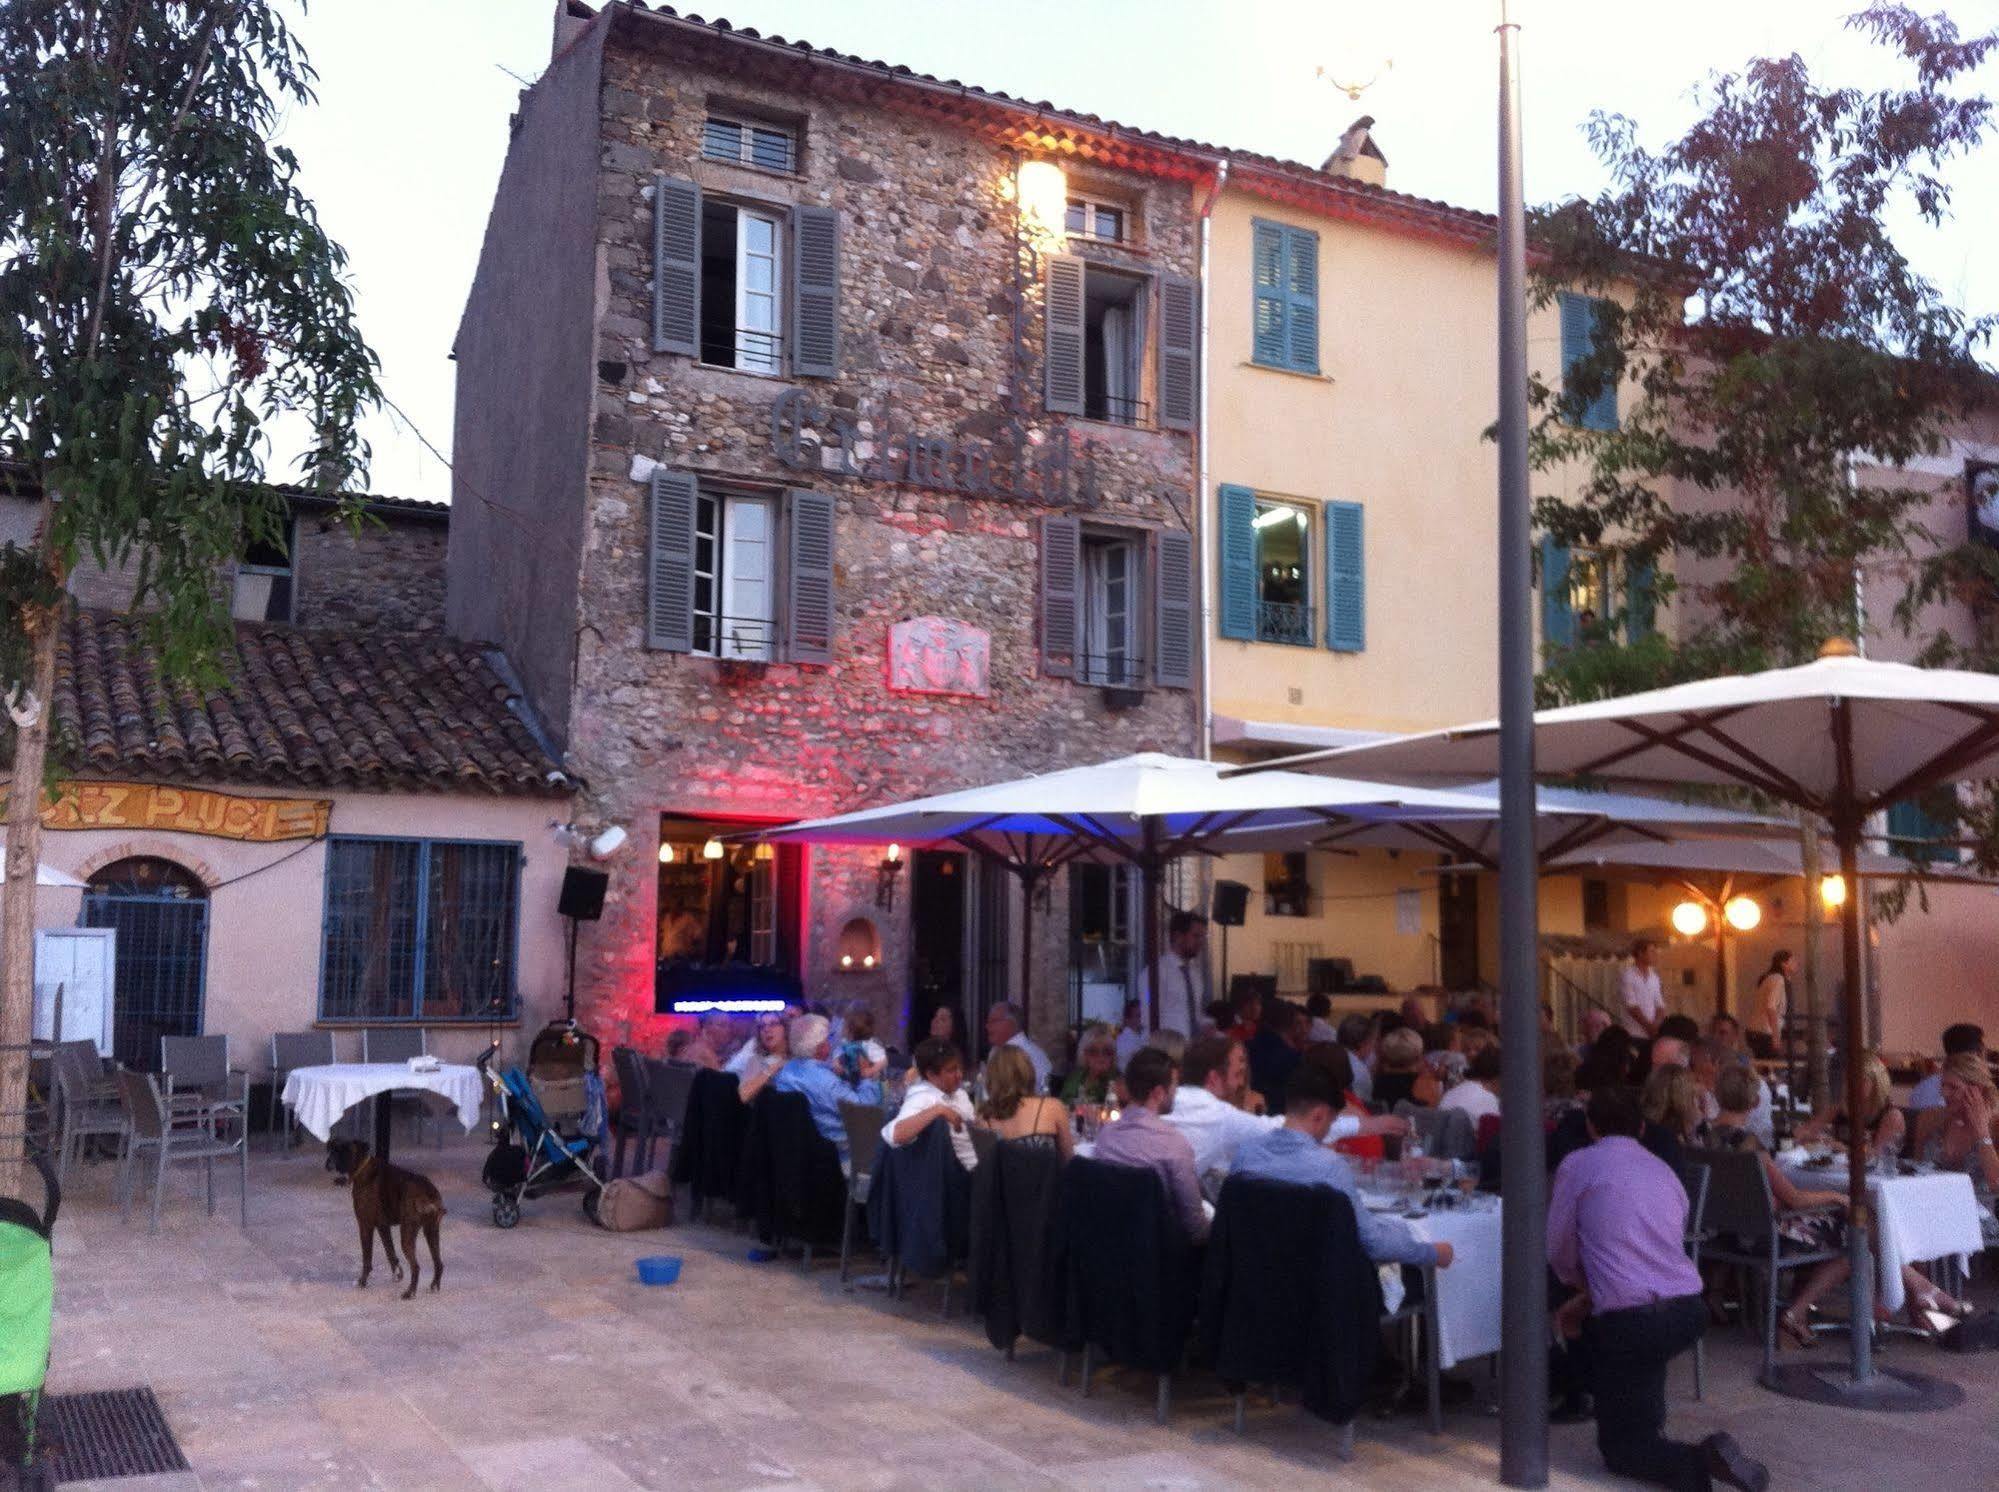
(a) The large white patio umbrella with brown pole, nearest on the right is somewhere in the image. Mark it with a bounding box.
[1273,640,1999,1408]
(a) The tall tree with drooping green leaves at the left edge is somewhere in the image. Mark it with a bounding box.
[0,0,378,1190]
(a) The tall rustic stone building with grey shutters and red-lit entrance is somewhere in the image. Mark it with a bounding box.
[448,2,1207,1040]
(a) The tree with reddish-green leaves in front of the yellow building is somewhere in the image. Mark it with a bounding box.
[1531,2,1999,1078]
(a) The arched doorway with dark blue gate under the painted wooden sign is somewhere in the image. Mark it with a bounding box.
[84,856,208,1072]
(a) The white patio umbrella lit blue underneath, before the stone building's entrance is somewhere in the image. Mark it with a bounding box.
[758,752,1491,1026]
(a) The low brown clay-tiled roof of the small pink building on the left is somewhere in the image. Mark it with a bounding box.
[54,610,556,794]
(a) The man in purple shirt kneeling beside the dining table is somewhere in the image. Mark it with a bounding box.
[1547,1088,1769,1492]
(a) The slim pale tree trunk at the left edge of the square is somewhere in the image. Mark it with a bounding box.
[0,608,62,1196]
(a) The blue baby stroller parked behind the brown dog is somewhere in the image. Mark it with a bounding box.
[478,1020,604,1228]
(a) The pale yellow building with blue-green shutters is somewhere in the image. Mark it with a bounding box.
[1201,126,1713,1010]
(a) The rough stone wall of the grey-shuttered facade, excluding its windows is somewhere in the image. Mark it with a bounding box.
[568,34,1197,1040]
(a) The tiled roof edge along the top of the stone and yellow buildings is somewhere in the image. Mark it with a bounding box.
[599,0,1497,242]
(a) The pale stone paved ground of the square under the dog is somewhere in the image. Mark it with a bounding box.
[38,1142,1999,1492]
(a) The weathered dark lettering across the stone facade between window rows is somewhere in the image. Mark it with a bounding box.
[770,388,1099,508]
